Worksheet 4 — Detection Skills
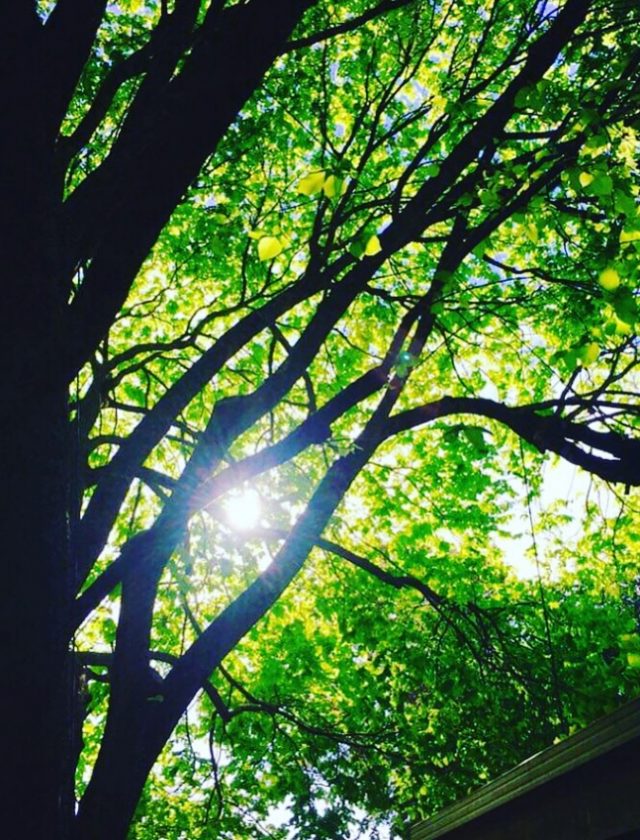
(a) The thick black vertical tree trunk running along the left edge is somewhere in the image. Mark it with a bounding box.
[0,123,73,840]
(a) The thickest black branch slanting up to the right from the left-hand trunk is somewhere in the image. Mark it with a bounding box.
[61,0,313,380]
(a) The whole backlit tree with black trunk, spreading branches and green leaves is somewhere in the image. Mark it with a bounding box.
[0,0,640,840]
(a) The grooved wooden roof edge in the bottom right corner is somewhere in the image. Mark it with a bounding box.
[410,698,640,840]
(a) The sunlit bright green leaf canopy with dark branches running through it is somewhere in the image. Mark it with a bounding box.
[36,0,640,838]
